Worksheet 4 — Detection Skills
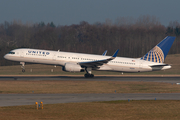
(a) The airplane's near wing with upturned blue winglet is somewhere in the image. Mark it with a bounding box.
[78,49,119,68]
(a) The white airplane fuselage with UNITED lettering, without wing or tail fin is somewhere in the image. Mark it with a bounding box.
[4,48,171,72]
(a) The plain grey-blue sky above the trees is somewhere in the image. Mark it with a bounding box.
[0,0,180,26]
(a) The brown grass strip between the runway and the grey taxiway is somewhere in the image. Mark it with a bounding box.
[0,80,180,94]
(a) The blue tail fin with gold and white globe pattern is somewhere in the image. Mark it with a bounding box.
[141,36,176,63]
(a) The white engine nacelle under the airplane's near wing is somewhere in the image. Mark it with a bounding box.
[62,63,84,72]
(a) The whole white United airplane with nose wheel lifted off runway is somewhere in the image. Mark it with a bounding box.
[4,36,175,78]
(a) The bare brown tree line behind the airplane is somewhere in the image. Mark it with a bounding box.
[0,16,180,66]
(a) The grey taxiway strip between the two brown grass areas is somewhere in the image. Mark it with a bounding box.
[0,93,180,106]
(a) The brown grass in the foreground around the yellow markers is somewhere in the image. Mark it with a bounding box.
[0,100,180,120]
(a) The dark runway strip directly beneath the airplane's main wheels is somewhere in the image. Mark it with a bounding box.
[0,75,180,83]
